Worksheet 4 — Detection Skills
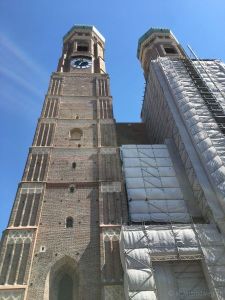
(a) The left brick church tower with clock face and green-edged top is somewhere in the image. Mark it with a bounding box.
[0,26,127,300]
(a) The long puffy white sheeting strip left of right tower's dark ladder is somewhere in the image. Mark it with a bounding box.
[156,58,225,218]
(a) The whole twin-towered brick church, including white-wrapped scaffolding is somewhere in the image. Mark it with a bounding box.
[0,25,225,300]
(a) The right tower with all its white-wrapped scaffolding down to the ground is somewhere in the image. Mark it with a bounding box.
[120,28,225,300]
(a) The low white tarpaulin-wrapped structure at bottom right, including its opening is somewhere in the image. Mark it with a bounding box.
[120,224,225,300]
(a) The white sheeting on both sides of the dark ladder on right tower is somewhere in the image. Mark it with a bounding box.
[159,58,225,216]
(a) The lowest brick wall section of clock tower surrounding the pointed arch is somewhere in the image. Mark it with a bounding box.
[28,186,100,299]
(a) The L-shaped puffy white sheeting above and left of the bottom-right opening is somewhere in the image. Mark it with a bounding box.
[120,225,199,300]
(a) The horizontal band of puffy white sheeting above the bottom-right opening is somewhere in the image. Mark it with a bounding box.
[121,225,199,258]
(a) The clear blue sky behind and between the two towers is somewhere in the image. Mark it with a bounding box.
[0,0,225,232]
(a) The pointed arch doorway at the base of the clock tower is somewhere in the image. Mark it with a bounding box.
[49,256,79,300]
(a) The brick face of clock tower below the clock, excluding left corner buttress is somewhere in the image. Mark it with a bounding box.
[24,69,127,300]
